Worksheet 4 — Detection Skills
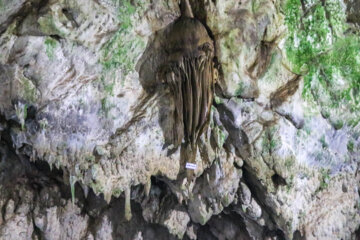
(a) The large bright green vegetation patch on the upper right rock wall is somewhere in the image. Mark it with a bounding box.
[283,0,360,124]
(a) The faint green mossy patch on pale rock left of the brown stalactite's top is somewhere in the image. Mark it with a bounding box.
[102,0,145,75]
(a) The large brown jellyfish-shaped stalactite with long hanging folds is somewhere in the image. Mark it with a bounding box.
[157,1,217,148]
